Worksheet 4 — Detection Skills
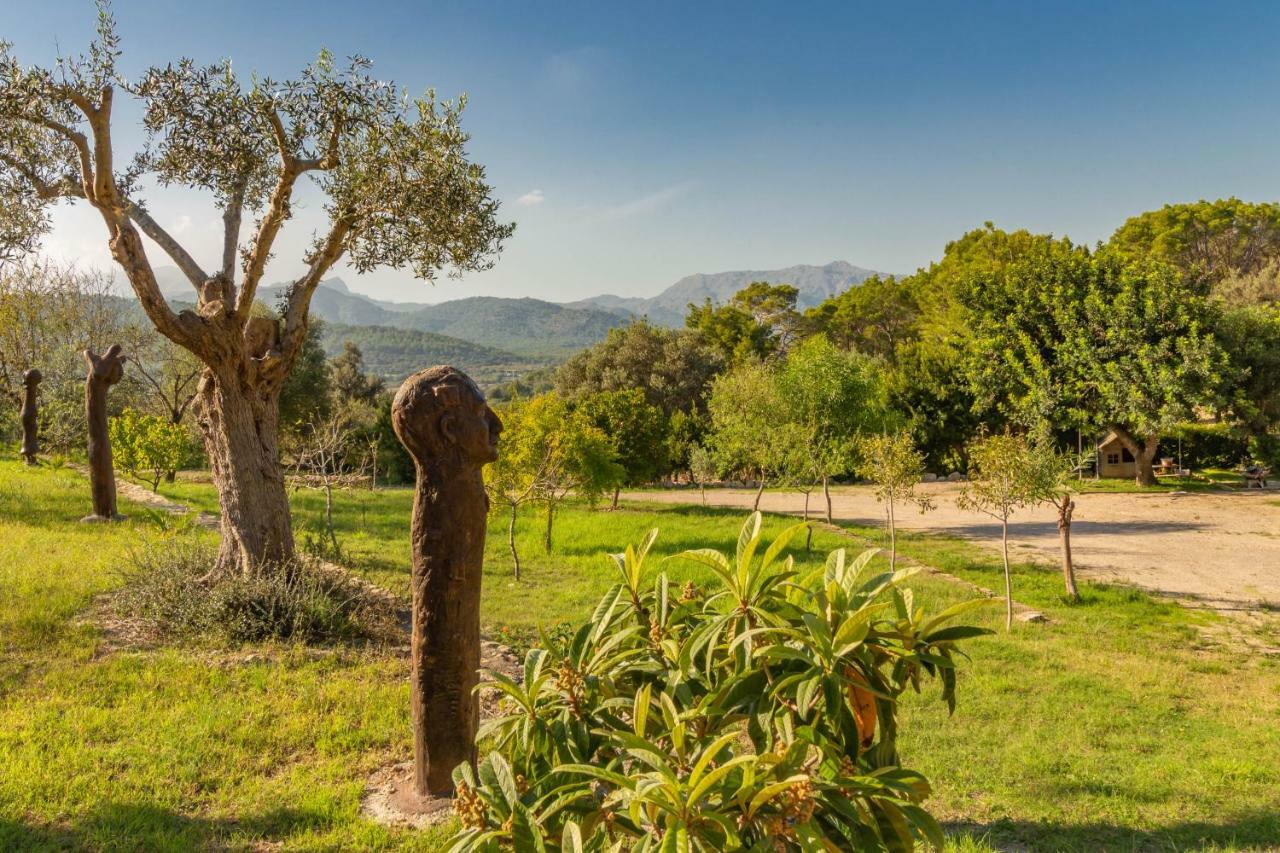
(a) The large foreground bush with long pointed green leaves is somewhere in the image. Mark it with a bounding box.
[449,514,987,850]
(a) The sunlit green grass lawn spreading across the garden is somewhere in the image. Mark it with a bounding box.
[0,459,1280,850]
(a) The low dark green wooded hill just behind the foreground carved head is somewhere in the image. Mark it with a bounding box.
[323,323,543,387]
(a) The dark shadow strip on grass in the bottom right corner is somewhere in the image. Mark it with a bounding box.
[943,811,1280,853]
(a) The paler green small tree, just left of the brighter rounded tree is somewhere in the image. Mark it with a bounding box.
[708,360,795,510]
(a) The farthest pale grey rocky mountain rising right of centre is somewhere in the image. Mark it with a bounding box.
[570,261,876,327]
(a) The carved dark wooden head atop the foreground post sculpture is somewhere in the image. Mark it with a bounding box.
[392,365,502,466]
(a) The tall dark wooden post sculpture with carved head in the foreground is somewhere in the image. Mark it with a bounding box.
[392,366,502,797]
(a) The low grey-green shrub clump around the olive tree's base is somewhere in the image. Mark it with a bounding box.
[116,538,403,644]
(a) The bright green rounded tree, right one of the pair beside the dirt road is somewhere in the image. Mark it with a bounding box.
[778,334,890,524]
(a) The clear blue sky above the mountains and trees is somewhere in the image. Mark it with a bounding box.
[0,0,1280,302]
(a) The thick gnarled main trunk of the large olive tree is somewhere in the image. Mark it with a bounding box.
[196,370,294,575]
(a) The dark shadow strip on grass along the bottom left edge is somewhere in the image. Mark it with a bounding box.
[0,803,333,850]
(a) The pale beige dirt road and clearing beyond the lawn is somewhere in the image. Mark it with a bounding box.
[631,483,1280,610]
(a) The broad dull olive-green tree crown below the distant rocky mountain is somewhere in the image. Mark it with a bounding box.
[556,320,724,418]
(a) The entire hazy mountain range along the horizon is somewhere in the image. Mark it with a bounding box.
[149,261,874,380]
